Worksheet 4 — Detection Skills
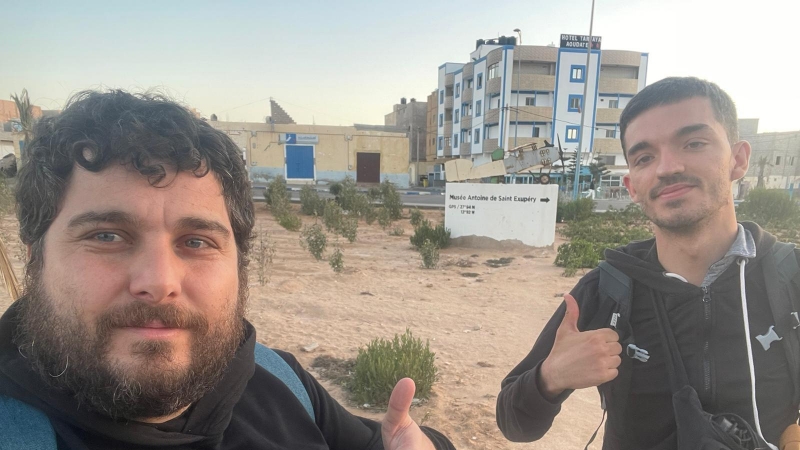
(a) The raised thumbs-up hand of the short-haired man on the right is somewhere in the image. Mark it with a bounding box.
[538,294,622,399]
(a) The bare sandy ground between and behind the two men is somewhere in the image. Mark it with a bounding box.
[0,209,602,449]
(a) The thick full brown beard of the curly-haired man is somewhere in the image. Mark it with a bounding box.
[14,267,247,420]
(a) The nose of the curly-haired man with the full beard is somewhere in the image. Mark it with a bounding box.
[129,240,184,303]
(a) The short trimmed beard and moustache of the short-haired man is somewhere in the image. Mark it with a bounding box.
[641,175,725,235]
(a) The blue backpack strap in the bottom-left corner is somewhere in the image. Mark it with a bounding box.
[0,395,57,450]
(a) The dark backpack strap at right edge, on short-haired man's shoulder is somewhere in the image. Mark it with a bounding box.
[763,242,800,403]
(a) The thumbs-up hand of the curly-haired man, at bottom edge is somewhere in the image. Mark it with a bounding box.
[381,378,435,450]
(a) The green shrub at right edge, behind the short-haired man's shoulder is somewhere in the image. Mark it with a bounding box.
[736,189,800,229]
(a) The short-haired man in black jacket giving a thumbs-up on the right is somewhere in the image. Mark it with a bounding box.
[497,78,800,449]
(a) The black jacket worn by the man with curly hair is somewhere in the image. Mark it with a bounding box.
[0,299,453,450]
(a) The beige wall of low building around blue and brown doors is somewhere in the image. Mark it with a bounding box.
[209,122,409,188]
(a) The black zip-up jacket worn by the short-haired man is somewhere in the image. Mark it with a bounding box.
[497,223,800,449]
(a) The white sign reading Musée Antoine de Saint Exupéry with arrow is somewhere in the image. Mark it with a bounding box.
[444,183,558,247]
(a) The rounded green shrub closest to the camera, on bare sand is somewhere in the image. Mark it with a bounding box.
[352,329,437,405]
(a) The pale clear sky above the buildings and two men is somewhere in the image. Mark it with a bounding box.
[0,0,800,131]
